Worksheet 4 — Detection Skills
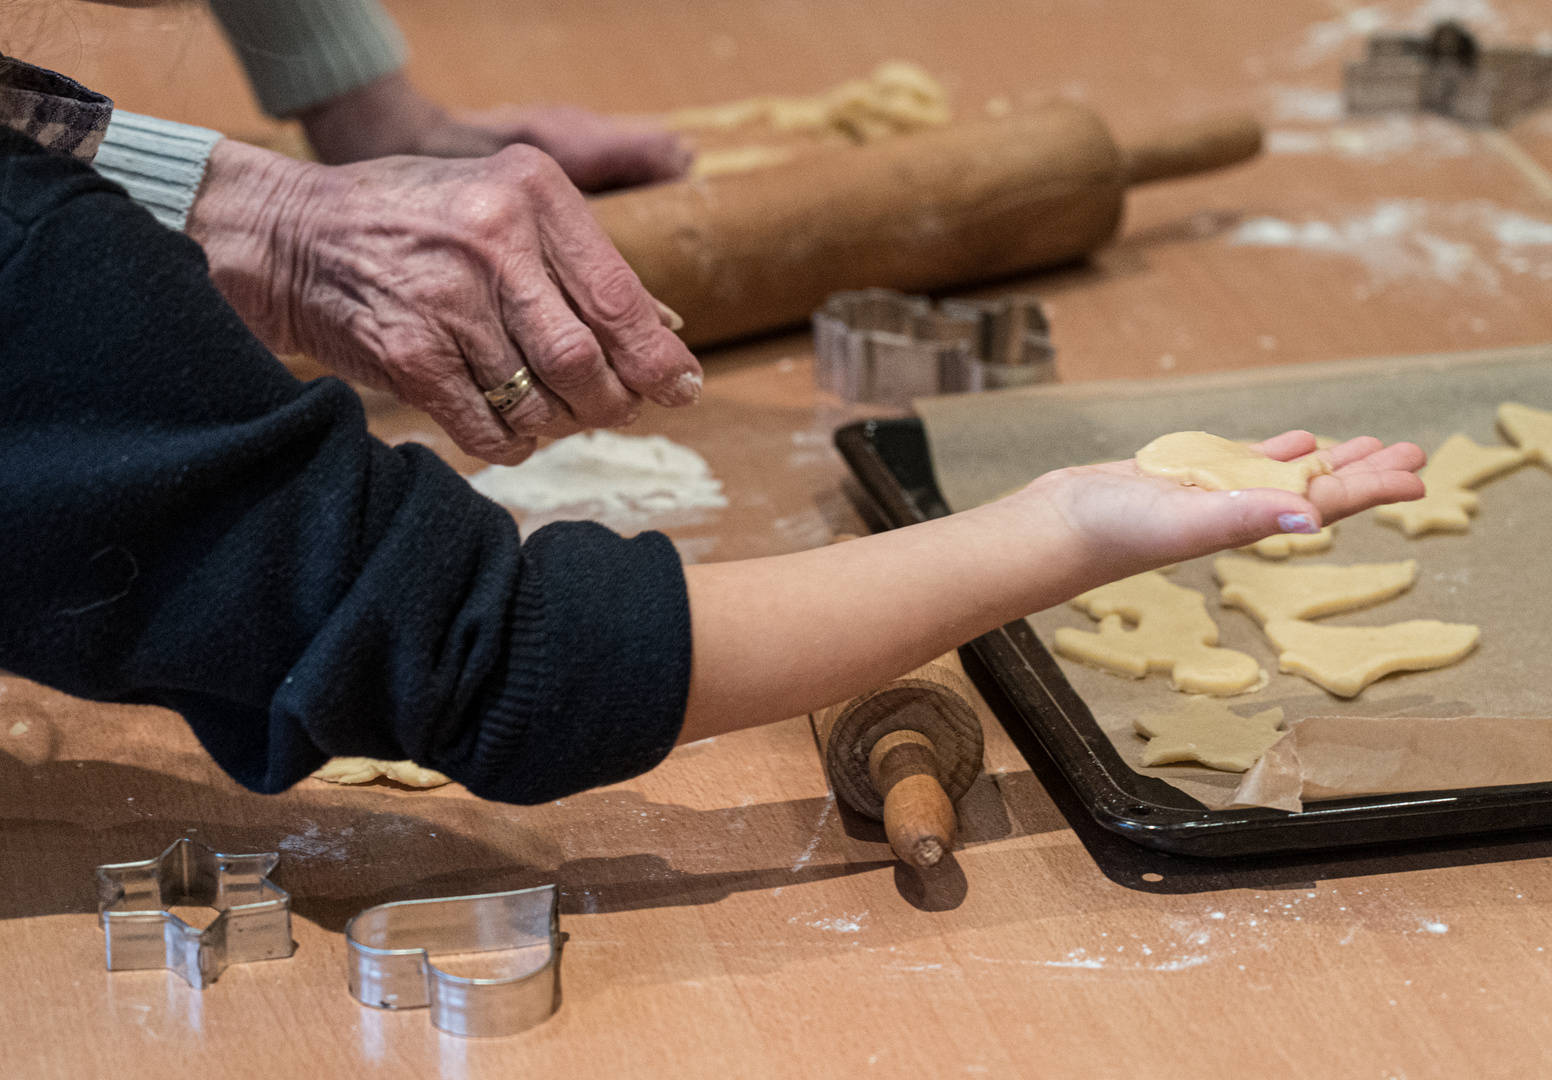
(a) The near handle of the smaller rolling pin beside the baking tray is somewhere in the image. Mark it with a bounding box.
[868,729,959,869]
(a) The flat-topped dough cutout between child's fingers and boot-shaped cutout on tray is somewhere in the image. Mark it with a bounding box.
[1212,557,1417,622]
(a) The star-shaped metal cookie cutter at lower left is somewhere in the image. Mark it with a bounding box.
[96,838,296,990]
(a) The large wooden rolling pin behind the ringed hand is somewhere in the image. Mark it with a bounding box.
[591,102,1262,346]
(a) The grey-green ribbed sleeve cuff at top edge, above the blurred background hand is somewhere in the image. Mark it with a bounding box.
[210,0,407,116]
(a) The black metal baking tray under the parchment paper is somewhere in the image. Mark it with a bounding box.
[835,417,1552,857]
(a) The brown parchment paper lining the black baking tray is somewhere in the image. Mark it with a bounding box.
[916,346,1552,808]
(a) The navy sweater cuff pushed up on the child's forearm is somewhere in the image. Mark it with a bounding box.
[458,521,691,805]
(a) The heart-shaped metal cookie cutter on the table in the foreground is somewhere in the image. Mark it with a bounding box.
[345,884,560,1035]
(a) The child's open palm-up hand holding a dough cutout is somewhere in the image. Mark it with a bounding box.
[1010,431,1426,580]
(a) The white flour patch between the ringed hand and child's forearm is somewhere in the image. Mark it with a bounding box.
[469,431,728,517]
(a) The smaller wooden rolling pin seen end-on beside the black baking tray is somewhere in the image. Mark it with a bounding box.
[813,653,986,867]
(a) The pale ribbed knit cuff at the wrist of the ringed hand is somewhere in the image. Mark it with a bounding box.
[92,109,225,231]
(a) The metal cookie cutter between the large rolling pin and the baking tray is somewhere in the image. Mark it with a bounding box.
[813,289,1055,405]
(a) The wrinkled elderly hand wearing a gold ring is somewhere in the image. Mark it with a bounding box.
[188,140,702,464]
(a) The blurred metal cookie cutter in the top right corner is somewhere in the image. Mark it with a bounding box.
[1342,20,1552,127]
